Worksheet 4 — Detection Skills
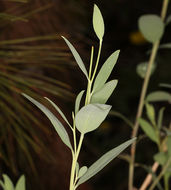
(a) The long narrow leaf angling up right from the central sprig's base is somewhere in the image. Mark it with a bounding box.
[77,138,136,186]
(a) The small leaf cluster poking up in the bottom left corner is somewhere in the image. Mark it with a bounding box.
[0,174,26,190]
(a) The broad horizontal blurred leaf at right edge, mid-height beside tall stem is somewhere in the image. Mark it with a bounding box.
[146,91,171,102]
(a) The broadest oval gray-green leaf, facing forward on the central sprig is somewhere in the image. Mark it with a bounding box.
[75,104,111,134]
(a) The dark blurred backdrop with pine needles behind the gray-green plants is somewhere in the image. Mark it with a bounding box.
[0,0,171,190]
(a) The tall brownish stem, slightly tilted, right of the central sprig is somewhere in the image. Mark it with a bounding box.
[128,0,169,190]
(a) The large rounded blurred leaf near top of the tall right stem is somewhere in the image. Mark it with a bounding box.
[138,14,164,43]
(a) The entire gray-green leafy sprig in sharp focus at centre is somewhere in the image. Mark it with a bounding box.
[23,5,135,190]
